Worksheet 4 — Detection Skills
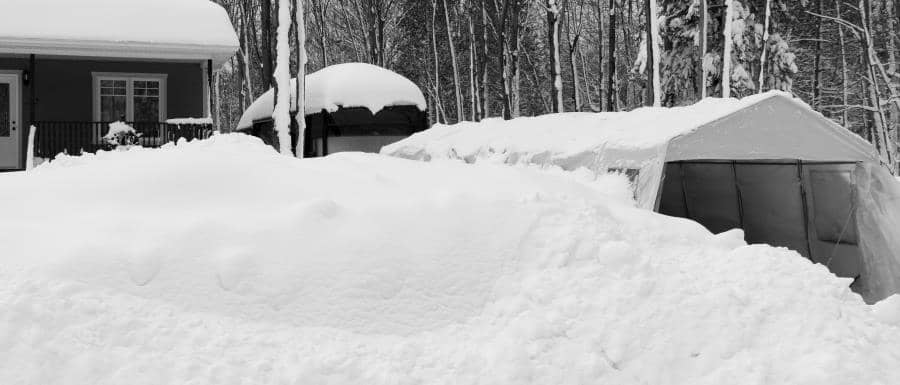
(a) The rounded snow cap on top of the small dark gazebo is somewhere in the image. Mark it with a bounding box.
[237,63,428,130]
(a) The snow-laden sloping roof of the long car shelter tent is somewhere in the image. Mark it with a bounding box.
[382,91,872,165]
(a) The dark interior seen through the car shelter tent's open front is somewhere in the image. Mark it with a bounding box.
[658,160,868,284]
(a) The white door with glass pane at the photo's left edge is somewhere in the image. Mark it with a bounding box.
[0,74,22,170]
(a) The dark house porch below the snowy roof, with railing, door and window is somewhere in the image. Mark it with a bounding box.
[0,52,213,170]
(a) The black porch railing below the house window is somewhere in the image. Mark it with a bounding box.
[34,121,213,159]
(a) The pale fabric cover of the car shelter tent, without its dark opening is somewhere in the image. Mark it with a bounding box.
[382,92,900,302]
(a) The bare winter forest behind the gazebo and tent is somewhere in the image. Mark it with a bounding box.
[207,0,900,163]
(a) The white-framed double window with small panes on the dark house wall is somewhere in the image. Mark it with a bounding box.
[94,73,166,122]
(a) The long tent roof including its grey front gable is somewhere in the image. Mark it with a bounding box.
[382,91,877,168]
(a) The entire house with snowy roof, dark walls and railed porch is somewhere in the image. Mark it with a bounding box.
[0,0,238,170]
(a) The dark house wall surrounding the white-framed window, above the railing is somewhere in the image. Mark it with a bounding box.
[0,56,204,164]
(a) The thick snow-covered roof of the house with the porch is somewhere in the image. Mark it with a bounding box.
[0,0,239,66]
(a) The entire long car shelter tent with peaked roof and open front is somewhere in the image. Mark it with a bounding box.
[382,92,900,302]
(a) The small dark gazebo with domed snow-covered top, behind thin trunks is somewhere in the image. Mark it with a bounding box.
[237,63,429,157]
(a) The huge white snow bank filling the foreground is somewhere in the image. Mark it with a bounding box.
[0,135,900,385]
